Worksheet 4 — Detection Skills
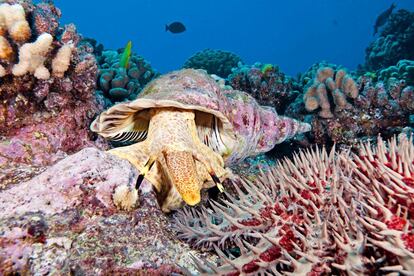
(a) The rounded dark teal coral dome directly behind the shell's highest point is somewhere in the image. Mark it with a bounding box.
[183,49,243,78]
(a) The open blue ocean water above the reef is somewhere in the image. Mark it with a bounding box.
[55,0,414,75]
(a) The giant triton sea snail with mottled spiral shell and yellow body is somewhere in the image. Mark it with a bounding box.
[91,69,310,212]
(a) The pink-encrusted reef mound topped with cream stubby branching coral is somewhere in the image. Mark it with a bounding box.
[0,1,106,187]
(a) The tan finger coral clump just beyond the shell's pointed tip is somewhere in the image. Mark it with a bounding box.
[303,67,358,118]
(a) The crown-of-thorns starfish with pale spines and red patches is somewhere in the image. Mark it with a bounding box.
[175,135,414,275]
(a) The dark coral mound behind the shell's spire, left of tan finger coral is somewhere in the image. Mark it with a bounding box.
[227,63,301,114]
